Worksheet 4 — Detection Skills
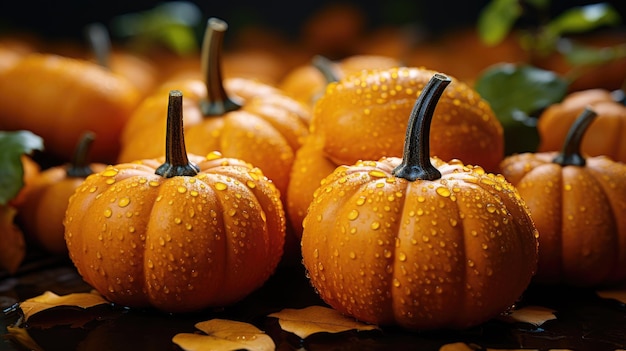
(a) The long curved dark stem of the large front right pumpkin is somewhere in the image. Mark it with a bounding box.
[393,73,451,182]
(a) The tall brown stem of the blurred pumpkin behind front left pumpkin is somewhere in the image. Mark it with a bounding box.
[200,18,241,116]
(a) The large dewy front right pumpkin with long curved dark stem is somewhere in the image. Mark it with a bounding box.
[302,74,537,330]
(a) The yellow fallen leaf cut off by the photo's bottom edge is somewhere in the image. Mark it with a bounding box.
[172,319,276,351]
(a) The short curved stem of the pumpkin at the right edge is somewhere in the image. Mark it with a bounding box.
[552,107,597,167]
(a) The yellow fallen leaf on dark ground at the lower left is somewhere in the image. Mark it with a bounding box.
[20,291,110,320]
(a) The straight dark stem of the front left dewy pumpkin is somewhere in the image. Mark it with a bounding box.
[154,90,200,178]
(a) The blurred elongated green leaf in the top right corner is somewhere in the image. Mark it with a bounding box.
[546,3,622,35]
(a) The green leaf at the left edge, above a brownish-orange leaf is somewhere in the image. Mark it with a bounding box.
[0,130,43,205]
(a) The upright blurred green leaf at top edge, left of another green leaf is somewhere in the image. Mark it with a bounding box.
[478,0,522,46]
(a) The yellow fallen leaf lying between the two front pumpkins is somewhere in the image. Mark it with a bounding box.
[269,306,378,339]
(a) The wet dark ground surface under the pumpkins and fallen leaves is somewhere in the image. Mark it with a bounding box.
[0,254,626,351]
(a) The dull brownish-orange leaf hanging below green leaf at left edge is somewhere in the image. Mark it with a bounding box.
[0,205,26,273]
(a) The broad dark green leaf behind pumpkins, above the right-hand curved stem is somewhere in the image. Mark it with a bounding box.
[475,63,569,154]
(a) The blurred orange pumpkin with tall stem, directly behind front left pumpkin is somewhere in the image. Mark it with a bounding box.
[119,18,310,197]
